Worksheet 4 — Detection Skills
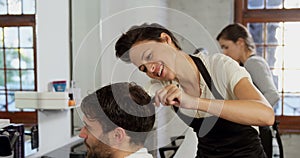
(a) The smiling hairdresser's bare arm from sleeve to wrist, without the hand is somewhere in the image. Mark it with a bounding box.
[197,78,275,126]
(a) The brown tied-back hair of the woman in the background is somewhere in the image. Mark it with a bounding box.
[217,23,256,52]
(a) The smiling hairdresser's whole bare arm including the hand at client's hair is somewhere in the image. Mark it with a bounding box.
[155,78,274,126]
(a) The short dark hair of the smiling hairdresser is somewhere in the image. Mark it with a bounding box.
[115,23,181,63]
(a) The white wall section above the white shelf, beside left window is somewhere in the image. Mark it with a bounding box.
[36,0,70,92]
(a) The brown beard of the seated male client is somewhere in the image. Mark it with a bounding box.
[85,141,113,158]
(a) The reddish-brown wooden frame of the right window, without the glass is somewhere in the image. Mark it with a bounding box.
[234,0,300,134]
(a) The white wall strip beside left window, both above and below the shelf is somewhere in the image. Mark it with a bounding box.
[29,0,77,157]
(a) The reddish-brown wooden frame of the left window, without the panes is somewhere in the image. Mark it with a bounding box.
[0,14,37,126]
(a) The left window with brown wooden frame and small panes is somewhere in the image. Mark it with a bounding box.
[0,0,37,124]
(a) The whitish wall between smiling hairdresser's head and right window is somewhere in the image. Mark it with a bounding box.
[168,0,233,53]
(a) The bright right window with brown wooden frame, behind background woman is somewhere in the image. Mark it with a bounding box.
[235,0,300,133]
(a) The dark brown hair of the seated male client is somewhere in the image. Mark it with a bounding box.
[81,82,155,144]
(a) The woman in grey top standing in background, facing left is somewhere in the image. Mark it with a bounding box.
[217,23,279,157]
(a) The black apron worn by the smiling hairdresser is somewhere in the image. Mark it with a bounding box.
[173,56,266,158]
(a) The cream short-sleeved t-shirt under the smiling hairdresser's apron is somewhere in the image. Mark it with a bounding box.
[180,53,252,118]
